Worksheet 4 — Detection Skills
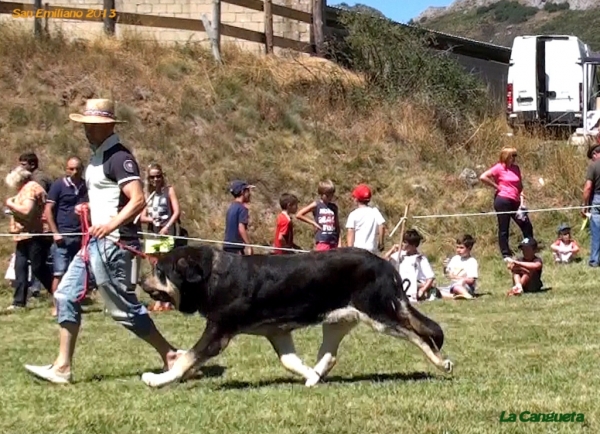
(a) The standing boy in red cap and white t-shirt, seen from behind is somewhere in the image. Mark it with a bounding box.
[346,184,385,254]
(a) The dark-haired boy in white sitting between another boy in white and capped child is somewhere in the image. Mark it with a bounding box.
[440,235,479,299]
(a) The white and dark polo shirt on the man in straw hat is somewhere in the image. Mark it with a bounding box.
[85,134,142,241]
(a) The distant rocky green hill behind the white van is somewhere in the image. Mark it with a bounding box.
[411,0,600,51]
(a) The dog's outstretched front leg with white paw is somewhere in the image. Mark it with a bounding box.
[142,322,231,387]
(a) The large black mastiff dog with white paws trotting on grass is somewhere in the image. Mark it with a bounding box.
[141,246,453,387]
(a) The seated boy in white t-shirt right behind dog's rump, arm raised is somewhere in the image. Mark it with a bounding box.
[384,229,435,301]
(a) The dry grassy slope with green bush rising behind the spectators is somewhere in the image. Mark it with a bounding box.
[0,13,586,259]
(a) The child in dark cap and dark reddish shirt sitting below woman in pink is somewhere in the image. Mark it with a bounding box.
[506,238,544,296]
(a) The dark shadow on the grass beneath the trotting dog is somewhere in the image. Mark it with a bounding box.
[215,372,450,390]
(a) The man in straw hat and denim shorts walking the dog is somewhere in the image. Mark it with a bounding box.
[25,99,183,383]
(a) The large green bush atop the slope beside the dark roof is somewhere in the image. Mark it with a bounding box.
[333,8,486,142]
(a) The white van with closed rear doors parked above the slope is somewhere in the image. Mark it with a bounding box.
[506,35,596,128]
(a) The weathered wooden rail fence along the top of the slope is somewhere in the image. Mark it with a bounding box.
[0,0,337,60]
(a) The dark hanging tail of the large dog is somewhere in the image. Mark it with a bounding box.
[392,267,444,353]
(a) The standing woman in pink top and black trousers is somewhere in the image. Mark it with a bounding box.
[479,148,533,258]
